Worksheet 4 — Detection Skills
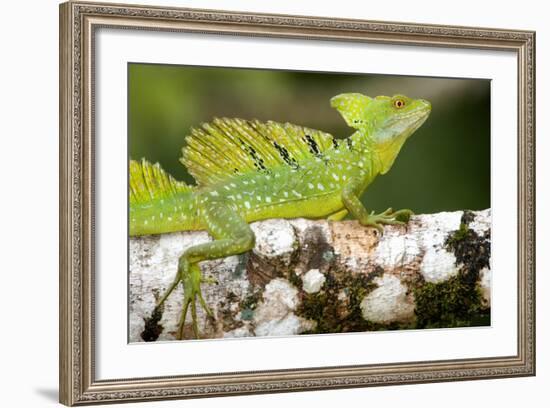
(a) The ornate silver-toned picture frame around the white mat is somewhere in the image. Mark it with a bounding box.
[59,2,535,405]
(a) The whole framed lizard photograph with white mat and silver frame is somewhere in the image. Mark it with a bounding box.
[60,2,535,405]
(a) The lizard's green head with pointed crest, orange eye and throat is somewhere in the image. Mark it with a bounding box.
[330,93,432,174]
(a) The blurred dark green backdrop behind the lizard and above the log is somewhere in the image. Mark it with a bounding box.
[128,63,491,213]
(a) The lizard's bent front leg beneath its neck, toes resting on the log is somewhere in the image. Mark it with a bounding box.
[342,179,413,234]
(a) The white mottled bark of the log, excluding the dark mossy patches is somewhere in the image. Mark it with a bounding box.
[129,210,491,342]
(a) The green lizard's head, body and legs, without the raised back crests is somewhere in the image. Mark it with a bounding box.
[130,93,431,339]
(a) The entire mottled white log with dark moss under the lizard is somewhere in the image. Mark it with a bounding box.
[129,209,491,342]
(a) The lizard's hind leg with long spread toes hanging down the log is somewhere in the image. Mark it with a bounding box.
[157,201,255,340]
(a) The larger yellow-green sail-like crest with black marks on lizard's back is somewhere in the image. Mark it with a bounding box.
[180,118,333,185]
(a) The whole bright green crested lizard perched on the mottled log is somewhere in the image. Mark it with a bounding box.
[129,93,431,339]
